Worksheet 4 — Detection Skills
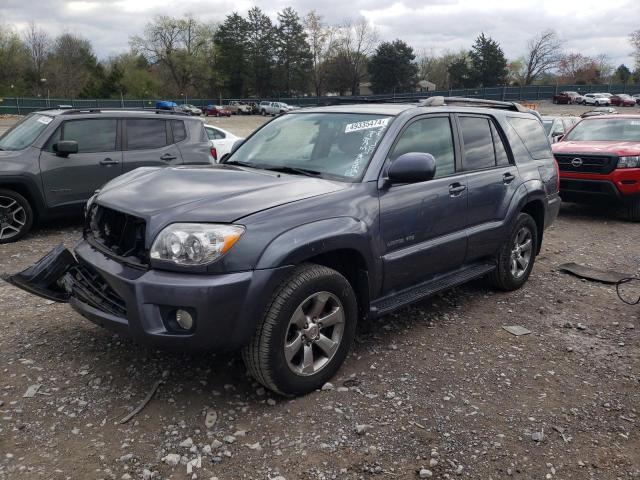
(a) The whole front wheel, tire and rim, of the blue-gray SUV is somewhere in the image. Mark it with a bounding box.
[242,264,358,396]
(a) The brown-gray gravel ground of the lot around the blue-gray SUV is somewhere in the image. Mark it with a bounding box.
[0,105,640,480]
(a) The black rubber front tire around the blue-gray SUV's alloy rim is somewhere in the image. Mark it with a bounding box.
[242,264,358,396]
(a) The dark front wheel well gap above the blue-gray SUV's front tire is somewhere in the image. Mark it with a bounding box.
[305,248,369,318]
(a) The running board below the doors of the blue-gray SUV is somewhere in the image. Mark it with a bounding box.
[370,263,496,317]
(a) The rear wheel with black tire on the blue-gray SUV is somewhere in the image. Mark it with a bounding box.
[488,213,538,292]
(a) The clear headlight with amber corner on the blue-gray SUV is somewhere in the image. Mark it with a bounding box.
[150,223,244,265]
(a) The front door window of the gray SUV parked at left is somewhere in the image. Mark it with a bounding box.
[62,118,118,153]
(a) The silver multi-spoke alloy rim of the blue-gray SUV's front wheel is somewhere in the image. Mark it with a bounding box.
[284,292,345,376]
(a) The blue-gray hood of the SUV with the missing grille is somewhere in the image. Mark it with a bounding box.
[94,164,347,224]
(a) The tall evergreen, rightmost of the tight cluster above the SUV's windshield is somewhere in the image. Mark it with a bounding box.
[275,7,312,96]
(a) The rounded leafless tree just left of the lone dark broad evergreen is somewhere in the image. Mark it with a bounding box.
[336,18,379,95]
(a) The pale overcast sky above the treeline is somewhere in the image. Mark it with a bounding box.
[0,0,640,67]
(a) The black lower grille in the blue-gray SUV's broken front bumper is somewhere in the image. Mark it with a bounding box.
[67,263,127,318]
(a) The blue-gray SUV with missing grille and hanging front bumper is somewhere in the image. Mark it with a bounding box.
[8,97,560,395]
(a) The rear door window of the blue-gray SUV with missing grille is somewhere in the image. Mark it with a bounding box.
[459,116,496,170]
